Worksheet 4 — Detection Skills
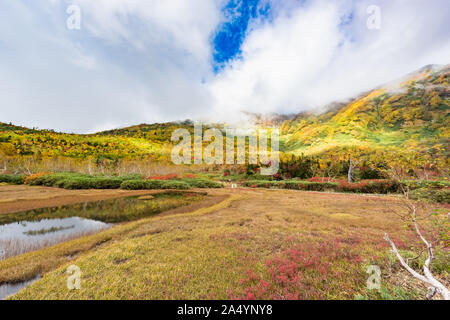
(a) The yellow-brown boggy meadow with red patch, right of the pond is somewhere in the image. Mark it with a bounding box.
[0,189,448,299]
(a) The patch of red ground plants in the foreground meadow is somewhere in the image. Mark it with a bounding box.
[228,236,366,300]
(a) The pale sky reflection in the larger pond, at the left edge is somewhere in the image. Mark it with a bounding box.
[0,217,109,241]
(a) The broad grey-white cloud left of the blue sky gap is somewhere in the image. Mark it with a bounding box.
[0,0,221,132]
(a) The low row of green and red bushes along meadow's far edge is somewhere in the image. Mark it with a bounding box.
[0,173,444,198]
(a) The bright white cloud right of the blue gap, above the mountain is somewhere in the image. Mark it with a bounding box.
[209,0,450,118]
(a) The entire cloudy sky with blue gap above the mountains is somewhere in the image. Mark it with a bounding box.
[0,0,450,133]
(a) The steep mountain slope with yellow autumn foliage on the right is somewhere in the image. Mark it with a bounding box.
[281,66,450,164]
